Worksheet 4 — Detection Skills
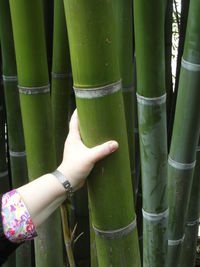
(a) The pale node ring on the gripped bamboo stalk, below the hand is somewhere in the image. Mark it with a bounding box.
[92,218,137,239]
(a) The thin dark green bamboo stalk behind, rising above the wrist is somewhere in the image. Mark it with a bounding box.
[51,0,72,165]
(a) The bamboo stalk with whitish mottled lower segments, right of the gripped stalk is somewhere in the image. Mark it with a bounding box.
[134,0,168,267]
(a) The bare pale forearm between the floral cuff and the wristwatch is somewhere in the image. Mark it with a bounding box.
[17,174,67,227]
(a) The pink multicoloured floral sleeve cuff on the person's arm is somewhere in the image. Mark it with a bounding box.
[1,189,37,243]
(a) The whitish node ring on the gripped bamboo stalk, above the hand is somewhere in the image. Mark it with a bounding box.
[74,80,122,99]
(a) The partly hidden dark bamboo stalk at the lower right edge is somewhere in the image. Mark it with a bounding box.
[180,140,200,267]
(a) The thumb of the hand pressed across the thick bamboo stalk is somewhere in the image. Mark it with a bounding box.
[90,141,119,163]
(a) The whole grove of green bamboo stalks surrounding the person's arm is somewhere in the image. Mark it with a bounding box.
[0,0,200,267]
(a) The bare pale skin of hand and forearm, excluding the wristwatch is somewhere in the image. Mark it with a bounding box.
[17,110,118,227]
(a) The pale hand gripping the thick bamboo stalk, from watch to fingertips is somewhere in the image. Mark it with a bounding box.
[57,110,118,191]
